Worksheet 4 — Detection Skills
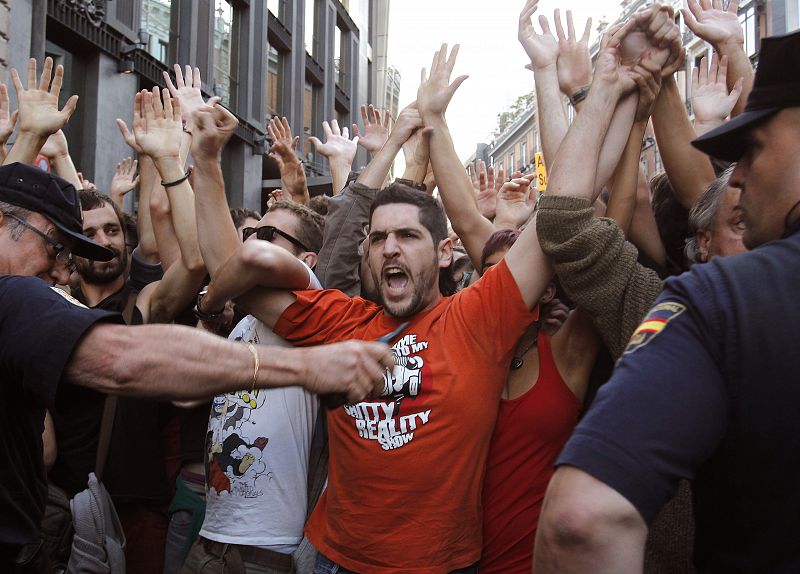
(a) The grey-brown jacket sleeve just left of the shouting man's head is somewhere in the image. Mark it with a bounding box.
[316,182,379,297]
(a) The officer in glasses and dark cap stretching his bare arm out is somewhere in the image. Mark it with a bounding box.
[0,163,393,572]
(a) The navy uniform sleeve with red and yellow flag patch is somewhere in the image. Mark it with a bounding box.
[556,266,729,523]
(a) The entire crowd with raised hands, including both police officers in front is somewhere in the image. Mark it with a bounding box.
[0,0,800,574]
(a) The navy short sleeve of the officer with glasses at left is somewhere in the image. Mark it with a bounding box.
[0,276,121,404]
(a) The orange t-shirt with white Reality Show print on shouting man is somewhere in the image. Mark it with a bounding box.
[274,262,537,574]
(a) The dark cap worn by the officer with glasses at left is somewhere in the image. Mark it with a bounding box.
[0,163,114,261]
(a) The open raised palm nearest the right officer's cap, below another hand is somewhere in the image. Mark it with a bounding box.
[691,52,743,135]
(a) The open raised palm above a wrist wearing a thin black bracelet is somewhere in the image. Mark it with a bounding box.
[133,86,183,161]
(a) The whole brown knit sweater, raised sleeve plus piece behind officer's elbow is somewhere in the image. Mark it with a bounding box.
[536,194,694,574]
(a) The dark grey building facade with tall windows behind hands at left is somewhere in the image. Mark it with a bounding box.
[0,0,389,210]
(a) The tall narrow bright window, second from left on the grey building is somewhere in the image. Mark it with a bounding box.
[213,0,239,109]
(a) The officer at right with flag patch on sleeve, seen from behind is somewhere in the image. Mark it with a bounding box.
[534,32,800,574]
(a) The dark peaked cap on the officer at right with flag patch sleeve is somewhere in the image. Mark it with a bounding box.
[692,32,800,161]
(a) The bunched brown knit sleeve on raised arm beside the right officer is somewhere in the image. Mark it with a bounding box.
[536,194,661,359]
